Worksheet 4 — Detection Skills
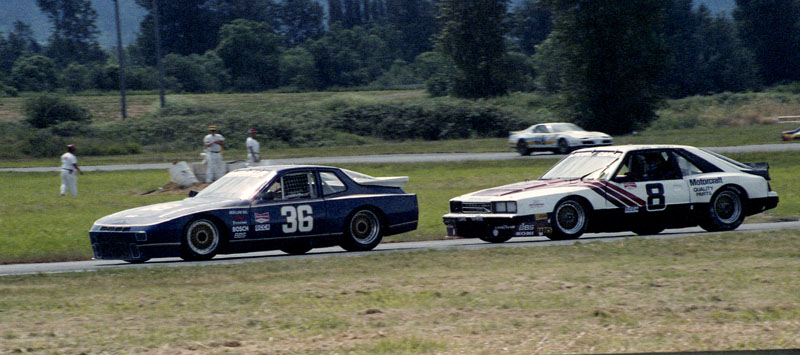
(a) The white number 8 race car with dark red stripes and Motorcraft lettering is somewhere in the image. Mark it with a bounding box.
[443,145,778,243]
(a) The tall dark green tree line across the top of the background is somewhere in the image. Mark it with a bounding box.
[0,0,800,133]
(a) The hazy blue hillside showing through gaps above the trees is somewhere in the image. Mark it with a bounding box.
[0,0,736,48]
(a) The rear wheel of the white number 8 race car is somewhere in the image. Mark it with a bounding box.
[700,186,745,232]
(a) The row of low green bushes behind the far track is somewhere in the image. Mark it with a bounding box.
[0,100,530,158]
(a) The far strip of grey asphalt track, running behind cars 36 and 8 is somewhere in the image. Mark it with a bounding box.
[0,143,800,172]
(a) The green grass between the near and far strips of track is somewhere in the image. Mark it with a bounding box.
[0,152,800,263]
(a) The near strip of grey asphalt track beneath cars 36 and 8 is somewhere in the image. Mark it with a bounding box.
[0,221,800,277]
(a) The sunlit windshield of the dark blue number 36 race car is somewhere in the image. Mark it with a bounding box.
[196,170,275,200]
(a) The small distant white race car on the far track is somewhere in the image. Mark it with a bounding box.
[508,123,613,155]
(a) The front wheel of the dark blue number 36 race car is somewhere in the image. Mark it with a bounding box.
[181,217,223,261]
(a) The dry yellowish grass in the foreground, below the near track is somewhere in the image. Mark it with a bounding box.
[0,231,800,354]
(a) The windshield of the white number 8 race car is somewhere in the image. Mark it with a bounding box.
[539,151,622,180]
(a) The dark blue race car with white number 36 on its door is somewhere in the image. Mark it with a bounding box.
[89,165,418,262]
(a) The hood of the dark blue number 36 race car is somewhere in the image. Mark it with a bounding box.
[94,197,247,225]
